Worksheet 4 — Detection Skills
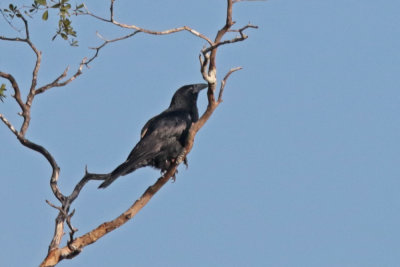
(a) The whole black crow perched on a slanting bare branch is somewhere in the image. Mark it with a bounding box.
[99,83,207,188]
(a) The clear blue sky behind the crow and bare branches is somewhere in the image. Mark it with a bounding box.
[0,0,400,267]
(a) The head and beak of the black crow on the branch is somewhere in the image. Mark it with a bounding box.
[169,83,208,110]
